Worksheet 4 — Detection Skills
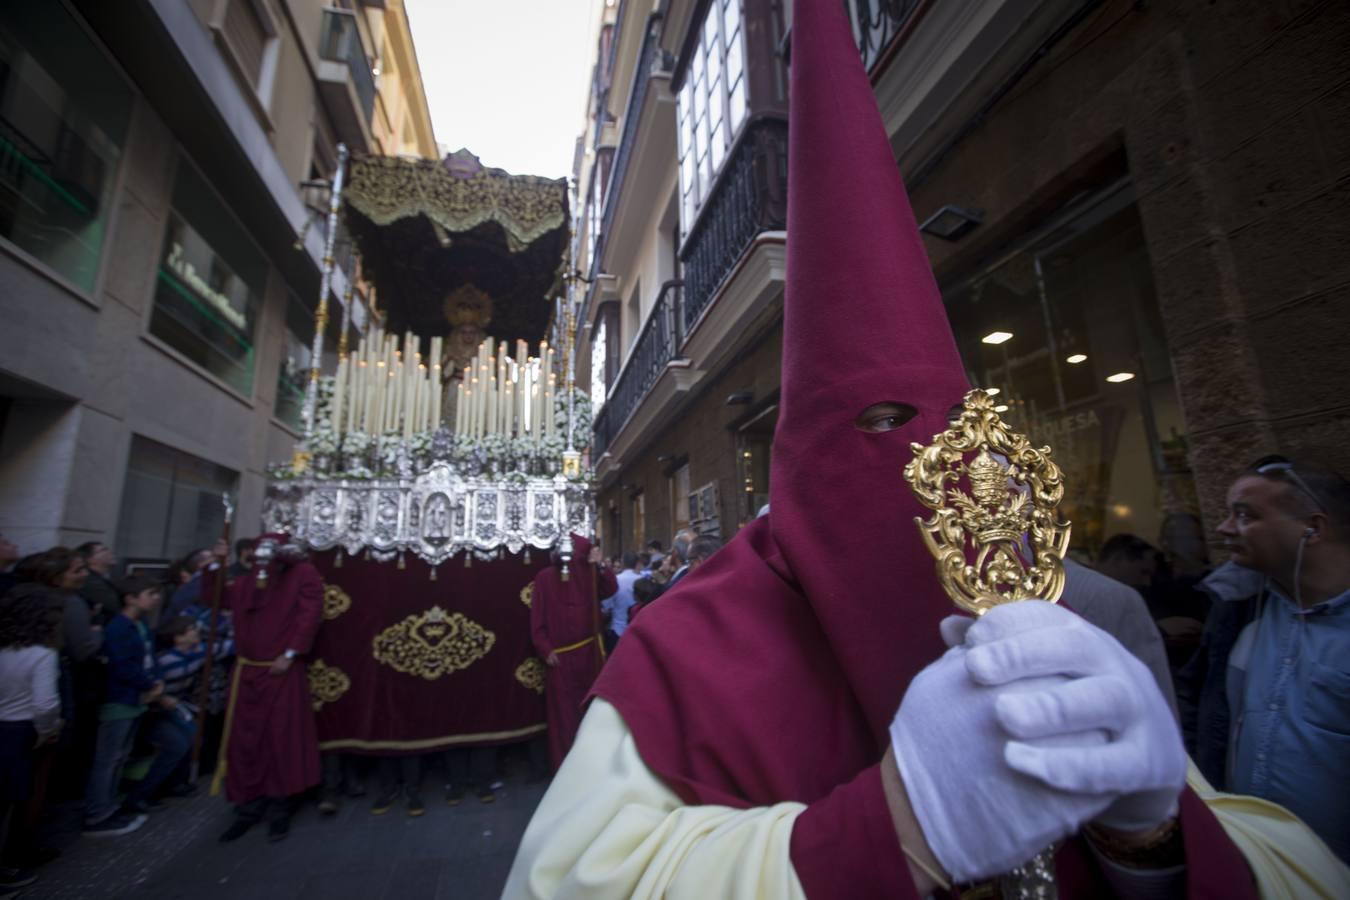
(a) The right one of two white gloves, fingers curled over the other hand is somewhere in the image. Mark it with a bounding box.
[965,602,1187,830]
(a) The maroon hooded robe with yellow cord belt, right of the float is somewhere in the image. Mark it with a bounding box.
[529,536,618,770]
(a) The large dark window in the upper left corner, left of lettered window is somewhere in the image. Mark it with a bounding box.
[0,3,132,294]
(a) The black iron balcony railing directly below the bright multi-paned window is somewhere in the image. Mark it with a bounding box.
[680,117,787,335]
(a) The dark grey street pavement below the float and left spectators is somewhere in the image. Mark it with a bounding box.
[18,770,547,900]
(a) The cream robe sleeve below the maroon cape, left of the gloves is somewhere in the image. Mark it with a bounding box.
[502,699,806,900]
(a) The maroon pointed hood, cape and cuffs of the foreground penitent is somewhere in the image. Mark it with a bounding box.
[594,0,1256,900]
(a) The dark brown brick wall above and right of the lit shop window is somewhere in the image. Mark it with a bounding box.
[914,0,1350,528]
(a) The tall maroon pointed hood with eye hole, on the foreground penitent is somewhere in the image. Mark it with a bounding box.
[770,0,968,733]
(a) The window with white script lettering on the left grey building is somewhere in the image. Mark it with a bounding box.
[150,159,267,397]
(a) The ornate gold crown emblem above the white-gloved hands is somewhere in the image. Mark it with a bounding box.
[905,390,1069,615]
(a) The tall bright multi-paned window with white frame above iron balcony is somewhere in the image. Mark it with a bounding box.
[676,0,747,241]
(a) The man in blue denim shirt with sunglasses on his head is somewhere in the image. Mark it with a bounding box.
[1177,456,1350,862]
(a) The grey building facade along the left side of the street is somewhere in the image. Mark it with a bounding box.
[0,0,435,563]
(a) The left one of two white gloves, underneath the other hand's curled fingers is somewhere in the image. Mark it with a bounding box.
[891,612,1115,882]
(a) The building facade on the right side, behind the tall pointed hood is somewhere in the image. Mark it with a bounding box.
[578,0,1350,557]
